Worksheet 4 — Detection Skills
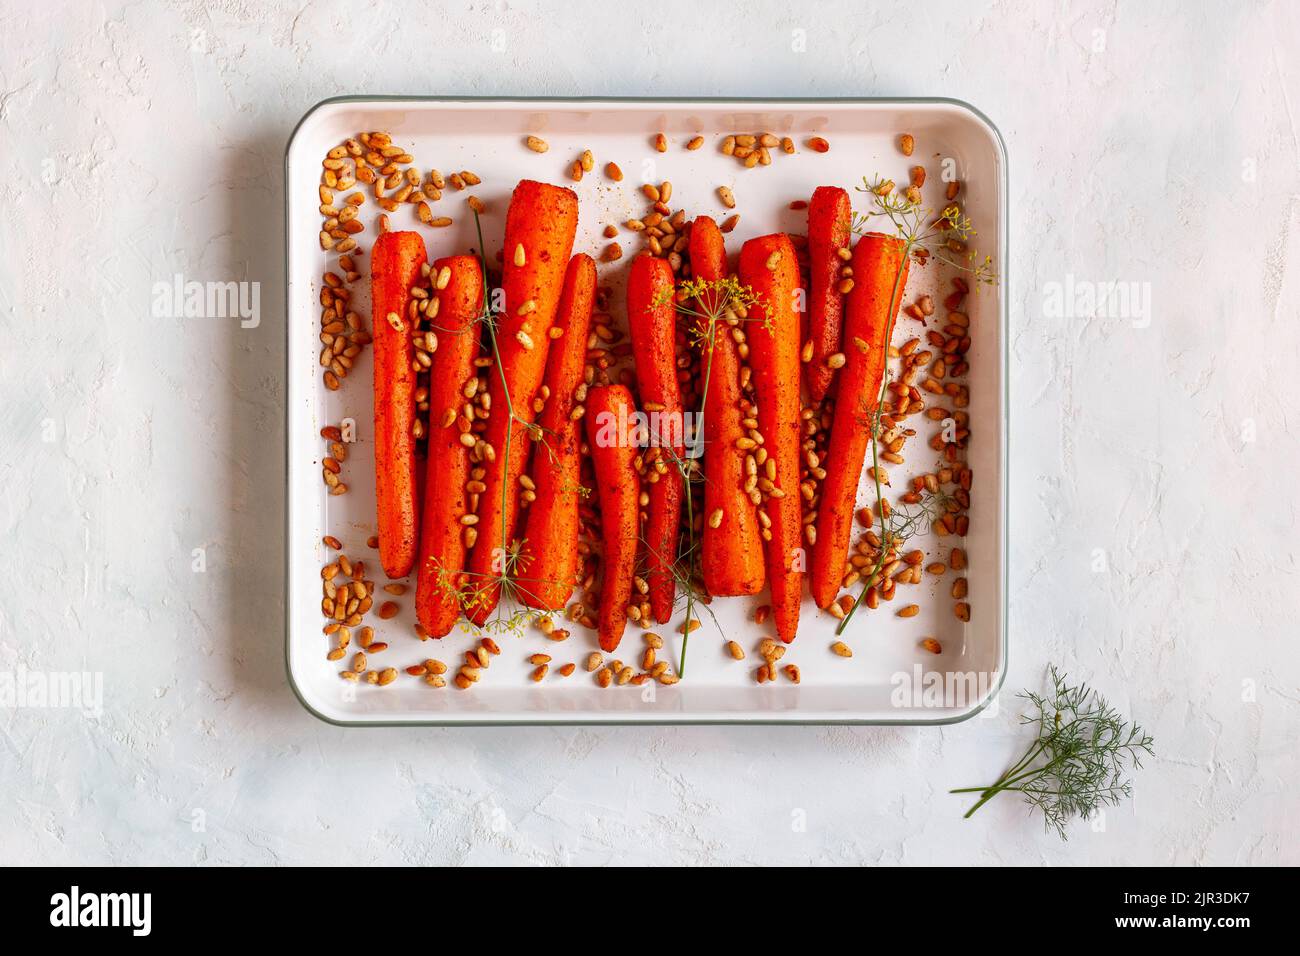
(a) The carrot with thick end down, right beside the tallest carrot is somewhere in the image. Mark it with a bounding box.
[520,254,595,611]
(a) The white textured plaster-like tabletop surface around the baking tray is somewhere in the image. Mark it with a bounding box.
[0,0,1300,864]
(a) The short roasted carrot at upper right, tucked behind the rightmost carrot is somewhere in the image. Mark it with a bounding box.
[806,186,853,402]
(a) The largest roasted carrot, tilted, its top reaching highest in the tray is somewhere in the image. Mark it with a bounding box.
[465,179,577,624]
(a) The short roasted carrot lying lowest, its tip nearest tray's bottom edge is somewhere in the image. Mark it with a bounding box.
[586,385,641,650]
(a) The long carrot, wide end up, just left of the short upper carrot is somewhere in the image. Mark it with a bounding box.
[740,233,806,644]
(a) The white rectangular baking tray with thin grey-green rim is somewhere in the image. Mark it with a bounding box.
[285,96,1008,726]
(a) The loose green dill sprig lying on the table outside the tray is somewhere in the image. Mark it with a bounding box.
[949,666,1154,840]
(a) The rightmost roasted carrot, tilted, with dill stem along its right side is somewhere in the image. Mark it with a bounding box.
[813,233,907,607]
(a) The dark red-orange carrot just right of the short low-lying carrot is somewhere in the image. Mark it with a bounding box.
[628,256,685,624]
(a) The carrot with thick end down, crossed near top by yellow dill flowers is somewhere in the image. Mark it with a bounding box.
[690,216,763,597]
